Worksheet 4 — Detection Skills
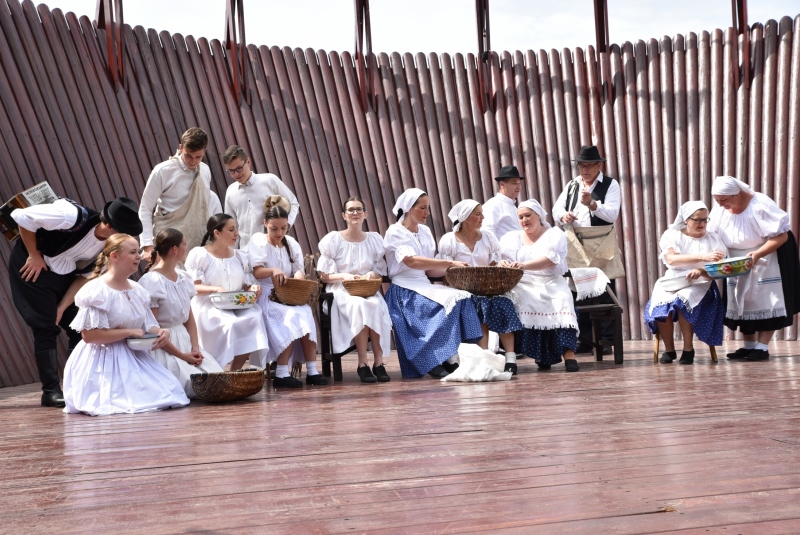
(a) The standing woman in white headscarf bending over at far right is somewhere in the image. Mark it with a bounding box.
[708,176,800,360]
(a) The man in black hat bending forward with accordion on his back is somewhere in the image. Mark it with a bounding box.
[8,197,142,407]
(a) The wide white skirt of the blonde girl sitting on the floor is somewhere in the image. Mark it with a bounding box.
[64,340,189,416]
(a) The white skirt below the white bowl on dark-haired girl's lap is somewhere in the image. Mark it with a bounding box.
[192,296,270,368]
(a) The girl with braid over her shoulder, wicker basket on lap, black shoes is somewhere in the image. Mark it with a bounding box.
[247,195,328,388]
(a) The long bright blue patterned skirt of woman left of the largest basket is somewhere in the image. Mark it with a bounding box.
[386,284,483,378]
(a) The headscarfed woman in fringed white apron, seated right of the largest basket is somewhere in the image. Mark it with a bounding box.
[498,199,579,372]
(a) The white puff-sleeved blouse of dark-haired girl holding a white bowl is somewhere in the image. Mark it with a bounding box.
[185,247,256,292]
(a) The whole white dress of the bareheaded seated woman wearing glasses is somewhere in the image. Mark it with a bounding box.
[317,231,392,357]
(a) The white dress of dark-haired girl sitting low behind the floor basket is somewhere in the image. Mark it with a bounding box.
[139,270,223,399]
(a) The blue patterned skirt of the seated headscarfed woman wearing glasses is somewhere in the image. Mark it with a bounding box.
[644,283,725,346]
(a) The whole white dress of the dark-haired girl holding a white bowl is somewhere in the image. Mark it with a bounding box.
[186,247,269,368]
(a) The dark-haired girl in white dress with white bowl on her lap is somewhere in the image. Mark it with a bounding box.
[186,214,269,370]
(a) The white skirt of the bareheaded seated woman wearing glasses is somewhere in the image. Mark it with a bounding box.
[328,282,392,358]
